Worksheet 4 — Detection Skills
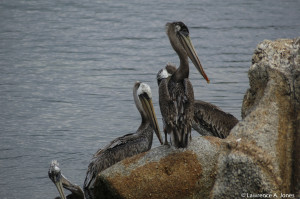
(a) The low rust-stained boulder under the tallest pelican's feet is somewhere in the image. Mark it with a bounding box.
[94,137,222,198]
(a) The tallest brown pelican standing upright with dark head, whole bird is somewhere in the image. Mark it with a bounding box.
[159,22,209,148]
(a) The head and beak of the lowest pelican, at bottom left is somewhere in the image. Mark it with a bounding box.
[48,160,66,199]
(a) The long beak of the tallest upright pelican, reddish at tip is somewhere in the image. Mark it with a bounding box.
[180,34,209,83]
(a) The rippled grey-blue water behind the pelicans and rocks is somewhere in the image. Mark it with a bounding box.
[0,0,300,199]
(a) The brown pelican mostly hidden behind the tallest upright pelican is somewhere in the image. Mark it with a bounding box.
[157,64,238,138]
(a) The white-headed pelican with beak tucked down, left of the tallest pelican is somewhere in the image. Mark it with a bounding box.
[84,82,163,189]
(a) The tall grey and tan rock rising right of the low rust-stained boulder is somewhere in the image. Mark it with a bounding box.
[211,39,300,198]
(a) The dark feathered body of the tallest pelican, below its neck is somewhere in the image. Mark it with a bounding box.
[159,78,194,147]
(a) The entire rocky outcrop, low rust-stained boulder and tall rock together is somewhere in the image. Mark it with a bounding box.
[90,39,300,198]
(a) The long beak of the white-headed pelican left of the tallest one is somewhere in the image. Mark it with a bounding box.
[139,95,163,144]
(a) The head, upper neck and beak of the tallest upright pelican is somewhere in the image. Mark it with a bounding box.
[166,22,209,83]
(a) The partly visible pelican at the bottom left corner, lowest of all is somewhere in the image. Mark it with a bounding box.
[48,160,84,199]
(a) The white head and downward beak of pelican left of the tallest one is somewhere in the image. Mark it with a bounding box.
[134,82,163,144]
